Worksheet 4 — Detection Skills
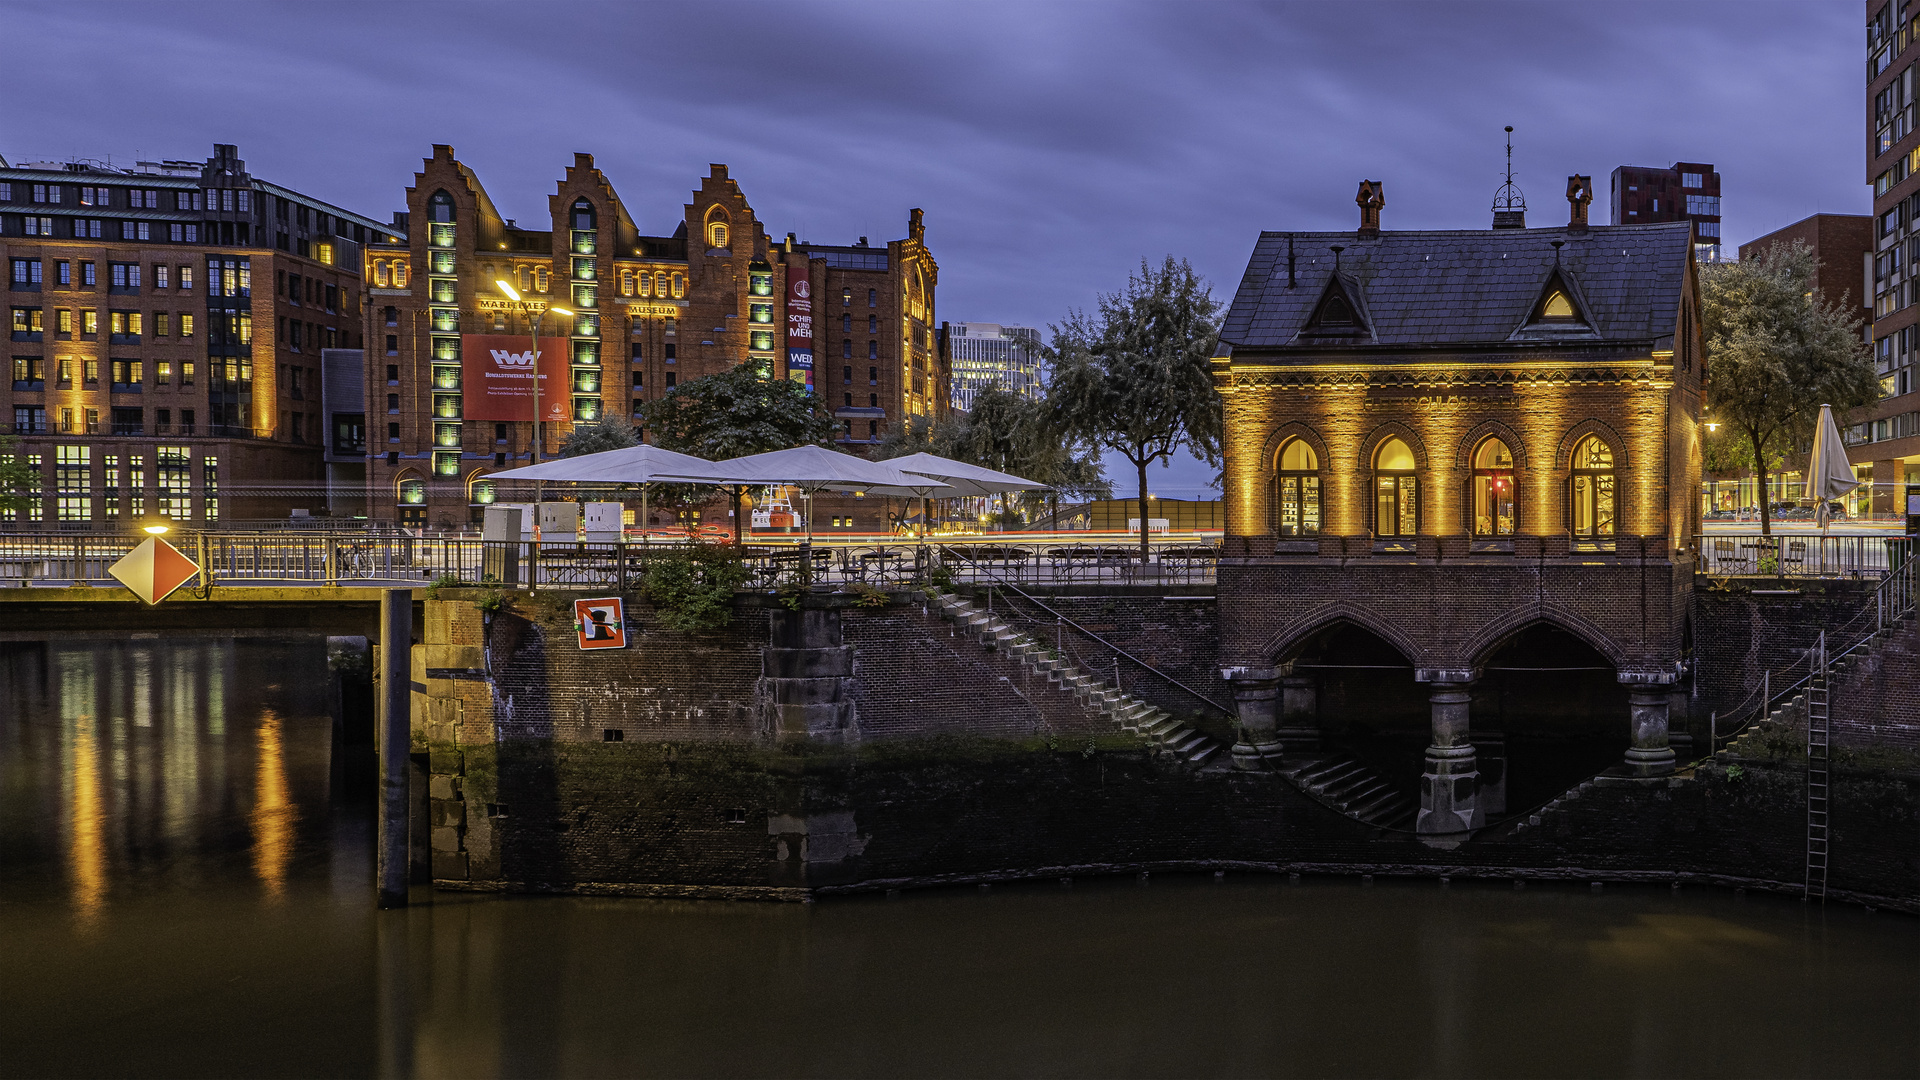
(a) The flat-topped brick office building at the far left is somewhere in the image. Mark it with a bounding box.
[0,144,392,530]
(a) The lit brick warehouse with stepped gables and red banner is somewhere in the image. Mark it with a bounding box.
[363,146,947,528]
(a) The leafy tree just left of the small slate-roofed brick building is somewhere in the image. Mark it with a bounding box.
[1046,256,1221,563]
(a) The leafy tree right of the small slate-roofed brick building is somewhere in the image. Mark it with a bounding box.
[1699,242,1880,534]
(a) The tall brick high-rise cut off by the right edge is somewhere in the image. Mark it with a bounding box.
[1845,0,1920,515]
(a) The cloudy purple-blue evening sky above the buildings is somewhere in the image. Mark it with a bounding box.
[0,0,1870,496]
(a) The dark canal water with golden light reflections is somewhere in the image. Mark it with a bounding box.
[0,638,1920,1076]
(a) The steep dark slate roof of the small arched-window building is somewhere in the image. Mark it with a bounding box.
[1219,221,1692,354]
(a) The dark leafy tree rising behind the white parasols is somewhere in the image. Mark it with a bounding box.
[641,363,833,544]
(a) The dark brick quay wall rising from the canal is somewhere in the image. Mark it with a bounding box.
[413,590,1920,911]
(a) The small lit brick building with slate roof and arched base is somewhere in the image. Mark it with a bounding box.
[1213,177,1705,832]
